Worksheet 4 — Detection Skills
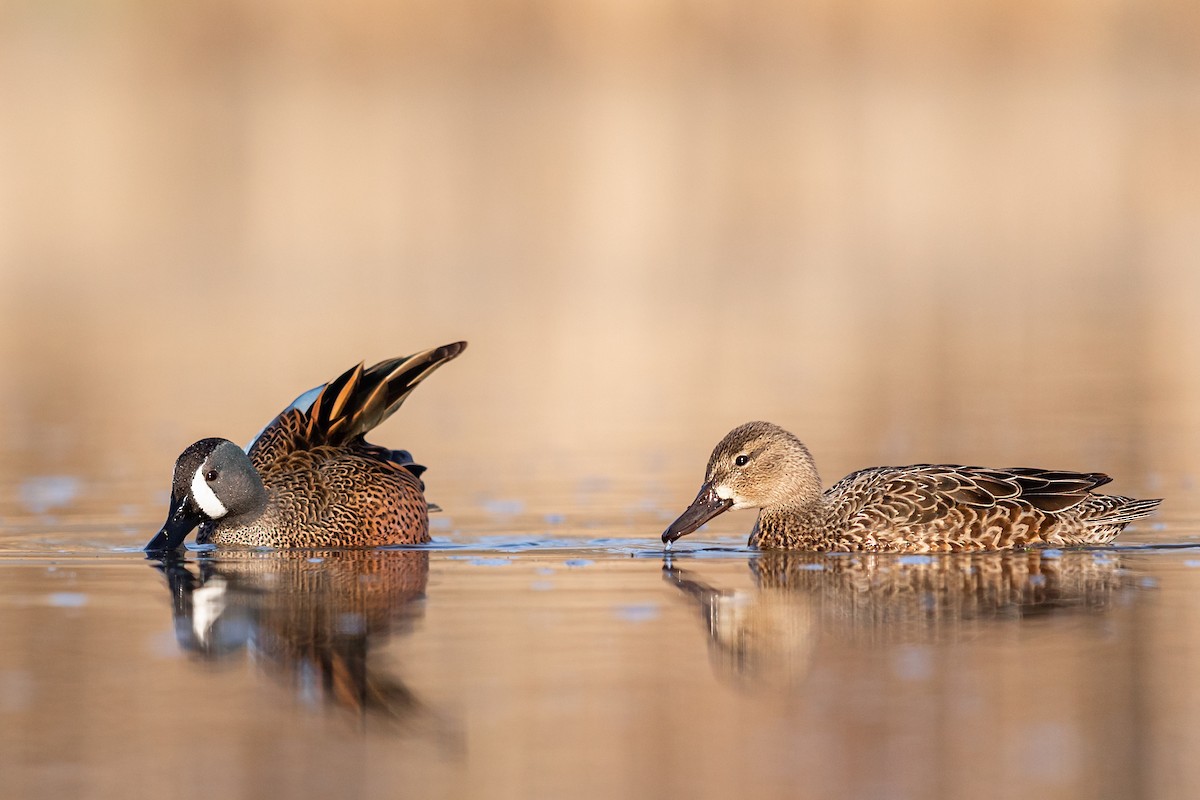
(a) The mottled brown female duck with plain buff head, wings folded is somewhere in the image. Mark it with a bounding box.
[662,422,1162,553]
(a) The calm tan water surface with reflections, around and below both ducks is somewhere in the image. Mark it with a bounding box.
[0,484,1200,798]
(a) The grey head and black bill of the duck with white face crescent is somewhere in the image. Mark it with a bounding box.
[145,439,266,552]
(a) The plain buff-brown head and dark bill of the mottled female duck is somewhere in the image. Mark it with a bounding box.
[662,422,821,543]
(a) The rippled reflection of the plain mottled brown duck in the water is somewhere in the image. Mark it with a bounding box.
[662,551,1135,685]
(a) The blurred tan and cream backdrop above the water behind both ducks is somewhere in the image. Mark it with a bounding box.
[0,0,1200,513]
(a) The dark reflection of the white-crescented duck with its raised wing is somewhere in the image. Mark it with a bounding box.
[155,549,439,721]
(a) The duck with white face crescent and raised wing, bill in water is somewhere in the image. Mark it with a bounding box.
[145,342,467,552]
